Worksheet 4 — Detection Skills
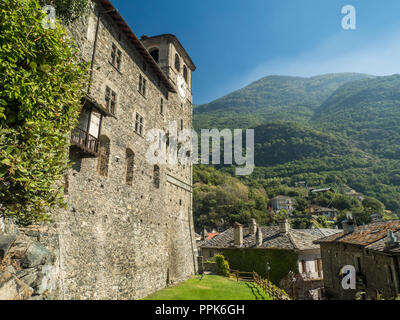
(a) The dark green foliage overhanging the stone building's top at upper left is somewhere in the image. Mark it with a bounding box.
[39,0,91,24]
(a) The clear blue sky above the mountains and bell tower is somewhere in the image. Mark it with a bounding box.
[113,0,400,104]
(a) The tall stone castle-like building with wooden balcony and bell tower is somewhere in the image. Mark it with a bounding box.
[42,0,197,299]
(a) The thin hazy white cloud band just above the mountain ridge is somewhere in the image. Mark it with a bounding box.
[226,30,400,92]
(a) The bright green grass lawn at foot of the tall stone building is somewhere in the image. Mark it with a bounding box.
[143,275,272,300]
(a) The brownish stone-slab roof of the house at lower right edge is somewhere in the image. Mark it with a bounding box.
[315,220,400,250]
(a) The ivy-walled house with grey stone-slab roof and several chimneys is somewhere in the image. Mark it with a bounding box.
[200,220,340,295]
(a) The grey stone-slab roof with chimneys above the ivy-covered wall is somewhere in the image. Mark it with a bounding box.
[200,226,338,250]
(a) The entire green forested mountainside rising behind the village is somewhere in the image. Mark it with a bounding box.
[194,73,400,220]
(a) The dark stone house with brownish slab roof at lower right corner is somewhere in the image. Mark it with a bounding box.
[314,220,400,300]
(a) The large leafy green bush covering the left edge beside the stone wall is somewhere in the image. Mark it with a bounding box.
[0,0,87,223]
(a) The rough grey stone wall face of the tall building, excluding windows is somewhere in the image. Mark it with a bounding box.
[0,1,197,299]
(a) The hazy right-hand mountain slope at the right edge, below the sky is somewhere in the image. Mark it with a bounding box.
[312,75,400,159]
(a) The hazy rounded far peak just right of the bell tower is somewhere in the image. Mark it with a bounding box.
[194,73,371,128]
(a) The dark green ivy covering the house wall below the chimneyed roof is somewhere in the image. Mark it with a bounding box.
[221,249,298,285]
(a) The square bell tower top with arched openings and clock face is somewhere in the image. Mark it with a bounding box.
[140,34,196,101]
